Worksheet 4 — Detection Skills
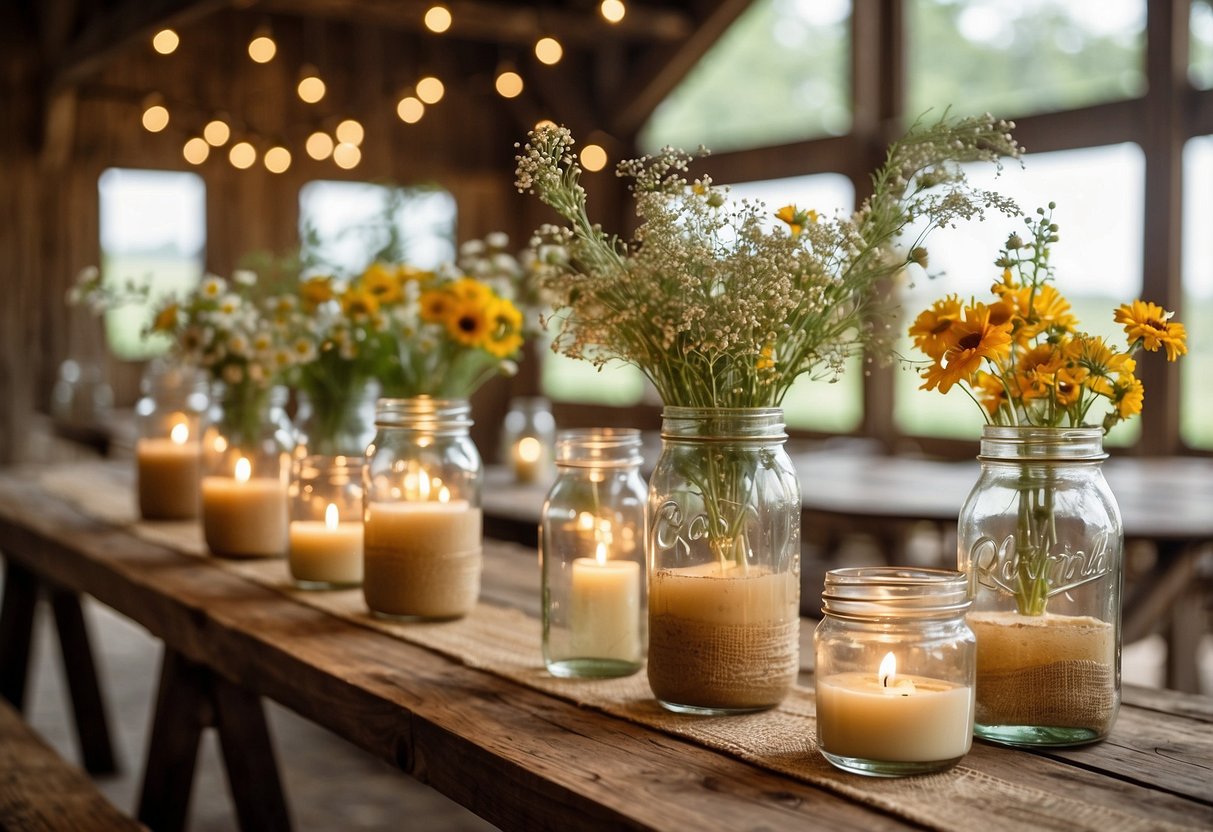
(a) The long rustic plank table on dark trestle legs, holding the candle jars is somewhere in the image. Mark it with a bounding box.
[0,466,1213,832]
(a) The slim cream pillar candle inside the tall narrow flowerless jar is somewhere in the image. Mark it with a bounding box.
[569,542,640,661]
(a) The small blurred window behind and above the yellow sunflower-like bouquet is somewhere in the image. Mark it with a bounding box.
[300,181,455,274]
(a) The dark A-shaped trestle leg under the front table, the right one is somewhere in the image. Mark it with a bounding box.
[138,648,291,832]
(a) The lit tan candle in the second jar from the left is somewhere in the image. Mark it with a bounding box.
[203,456,287,557]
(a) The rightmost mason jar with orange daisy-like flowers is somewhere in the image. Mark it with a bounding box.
[910,204,1186,746]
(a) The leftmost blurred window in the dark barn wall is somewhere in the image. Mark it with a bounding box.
[97,167,206,360]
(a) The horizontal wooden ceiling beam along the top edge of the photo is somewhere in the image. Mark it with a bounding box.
[256,0,693,49]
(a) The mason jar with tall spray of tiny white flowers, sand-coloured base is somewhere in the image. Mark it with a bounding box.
[517,116,1019,713]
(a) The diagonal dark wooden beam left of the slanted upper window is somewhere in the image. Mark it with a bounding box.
[608,0,752,141]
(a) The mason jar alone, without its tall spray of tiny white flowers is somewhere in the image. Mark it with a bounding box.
[647,408,801,713]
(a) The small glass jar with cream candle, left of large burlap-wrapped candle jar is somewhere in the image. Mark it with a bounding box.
[286,454,365,589]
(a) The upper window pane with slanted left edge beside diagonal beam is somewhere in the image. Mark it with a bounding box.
[639,0,850,150]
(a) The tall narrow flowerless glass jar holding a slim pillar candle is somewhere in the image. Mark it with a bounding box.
[540,428,648,677]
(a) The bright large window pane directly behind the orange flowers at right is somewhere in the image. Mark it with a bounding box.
[894,144,1150,445]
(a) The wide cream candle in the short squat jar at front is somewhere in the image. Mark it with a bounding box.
[816,653,973,763]
